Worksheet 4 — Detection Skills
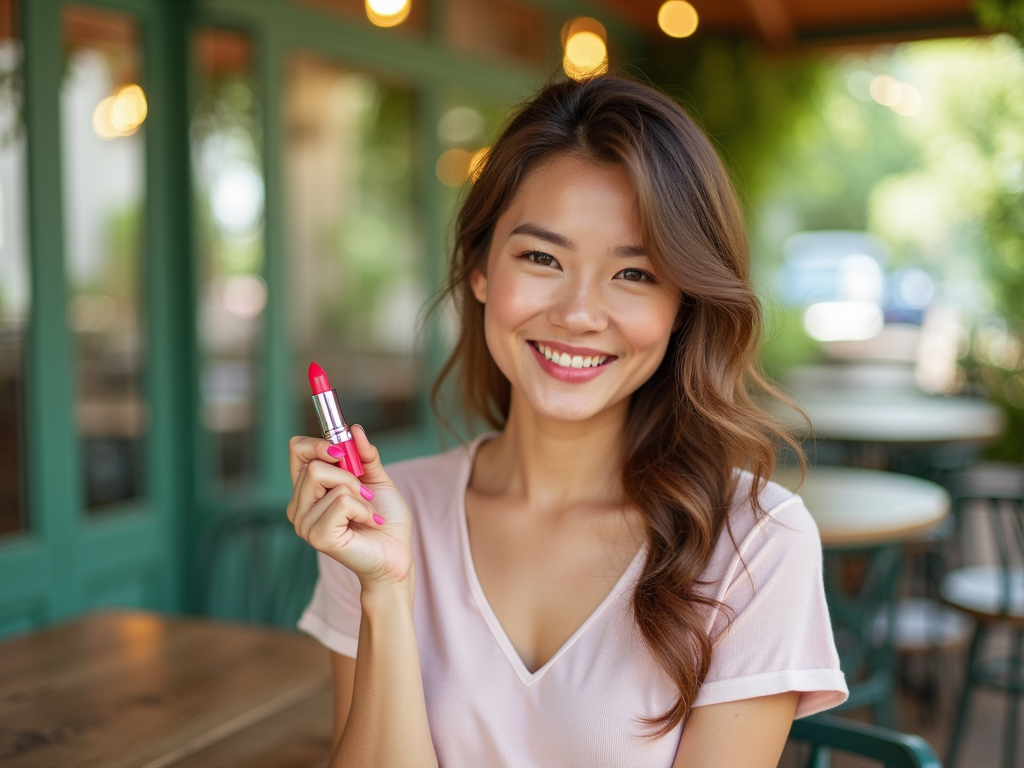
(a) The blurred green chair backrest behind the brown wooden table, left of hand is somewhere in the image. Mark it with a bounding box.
[193,506,316,629]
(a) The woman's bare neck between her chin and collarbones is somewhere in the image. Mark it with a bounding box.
[471,390,629,511]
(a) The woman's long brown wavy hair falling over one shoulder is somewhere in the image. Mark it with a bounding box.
[431,76,800,736]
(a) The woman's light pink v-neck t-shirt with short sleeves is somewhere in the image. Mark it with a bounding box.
[299,435,848,768]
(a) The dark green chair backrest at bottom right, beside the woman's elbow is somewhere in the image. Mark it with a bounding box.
[790,715,942,768]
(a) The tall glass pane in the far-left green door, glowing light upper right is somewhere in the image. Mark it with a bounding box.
[60,6,147,513]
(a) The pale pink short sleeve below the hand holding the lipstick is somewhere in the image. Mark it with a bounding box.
[299,553,362,658]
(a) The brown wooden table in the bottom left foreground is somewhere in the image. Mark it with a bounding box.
[0,610,333,768]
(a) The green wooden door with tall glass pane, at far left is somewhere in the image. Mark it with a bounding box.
[0,0,194,634]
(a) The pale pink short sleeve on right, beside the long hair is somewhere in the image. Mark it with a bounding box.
[693,496,849,718]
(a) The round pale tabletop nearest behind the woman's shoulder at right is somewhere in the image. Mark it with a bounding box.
[772,467,949,548]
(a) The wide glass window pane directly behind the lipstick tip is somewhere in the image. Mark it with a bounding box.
[285,54,425,434]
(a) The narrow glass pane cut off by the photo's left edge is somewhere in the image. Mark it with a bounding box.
[0,0,30,535]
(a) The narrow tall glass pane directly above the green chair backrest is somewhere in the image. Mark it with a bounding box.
[191,28,266,493]
